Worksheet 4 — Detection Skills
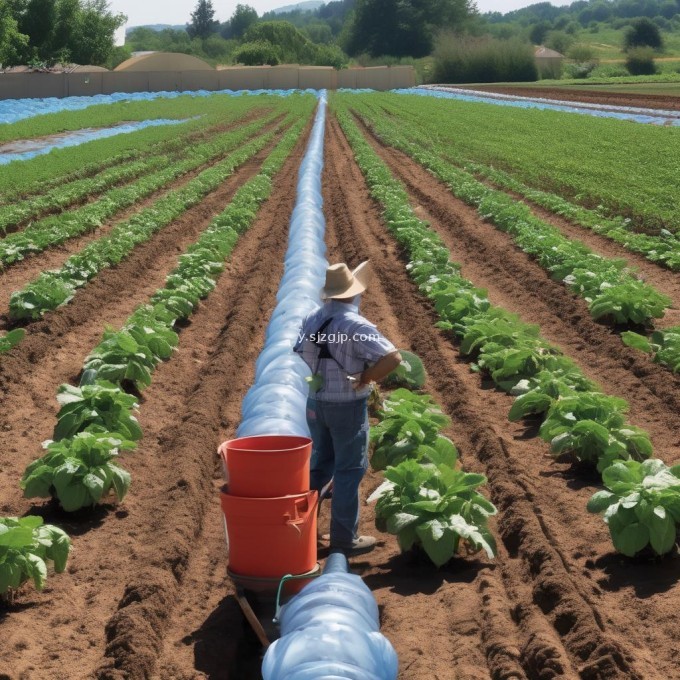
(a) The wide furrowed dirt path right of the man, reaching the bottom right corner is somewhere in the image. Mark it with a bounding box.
[326,115,680,680]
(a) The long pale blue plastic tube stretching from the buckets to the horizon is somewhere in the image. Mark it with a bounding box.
[236,90,328,437]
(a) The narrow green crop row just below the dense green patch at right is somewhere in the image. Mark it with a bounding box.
[358,99,680,271]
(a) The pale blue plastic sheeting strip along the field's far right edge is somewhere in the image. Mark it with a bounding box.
[392,86,680,126]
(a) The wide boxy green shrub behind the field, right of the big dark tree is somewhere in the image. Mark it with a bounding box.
[433,33,538,83]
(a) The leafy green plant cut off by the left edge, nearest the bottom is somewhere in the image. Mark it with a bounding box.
[0,515,71,596]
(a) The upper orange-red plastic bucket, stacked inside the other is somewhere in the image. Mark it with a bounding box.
[219,434,312,496]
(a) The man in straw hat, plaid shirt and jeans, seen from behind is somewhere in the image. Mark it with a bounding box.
[294,262,401,556]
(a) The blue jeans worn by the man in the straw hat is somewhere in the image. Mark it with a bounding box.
[307,398,368,548]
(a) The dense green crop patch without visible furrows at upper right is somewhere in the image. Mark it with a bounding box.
[372,93,680,233]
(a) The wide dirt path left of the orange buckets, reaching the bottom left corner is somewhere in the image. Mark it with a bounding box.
[0,119,310,680]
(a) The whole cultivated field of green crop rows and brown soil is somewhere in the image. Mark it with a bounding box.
[0,93,680,680]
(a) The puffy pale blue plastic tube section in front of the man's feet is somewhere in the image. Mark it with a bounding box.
[262,553,399,680]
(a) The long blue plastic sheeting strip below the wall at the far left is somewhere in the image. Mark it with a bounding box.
[0,90,318,123]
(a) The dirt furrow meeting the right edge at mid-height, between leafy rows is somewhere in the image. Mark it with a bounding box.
[354,115,680,462]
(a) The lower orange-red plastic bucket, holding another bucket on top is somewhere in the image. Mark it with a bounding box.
[220,486,319,579]
